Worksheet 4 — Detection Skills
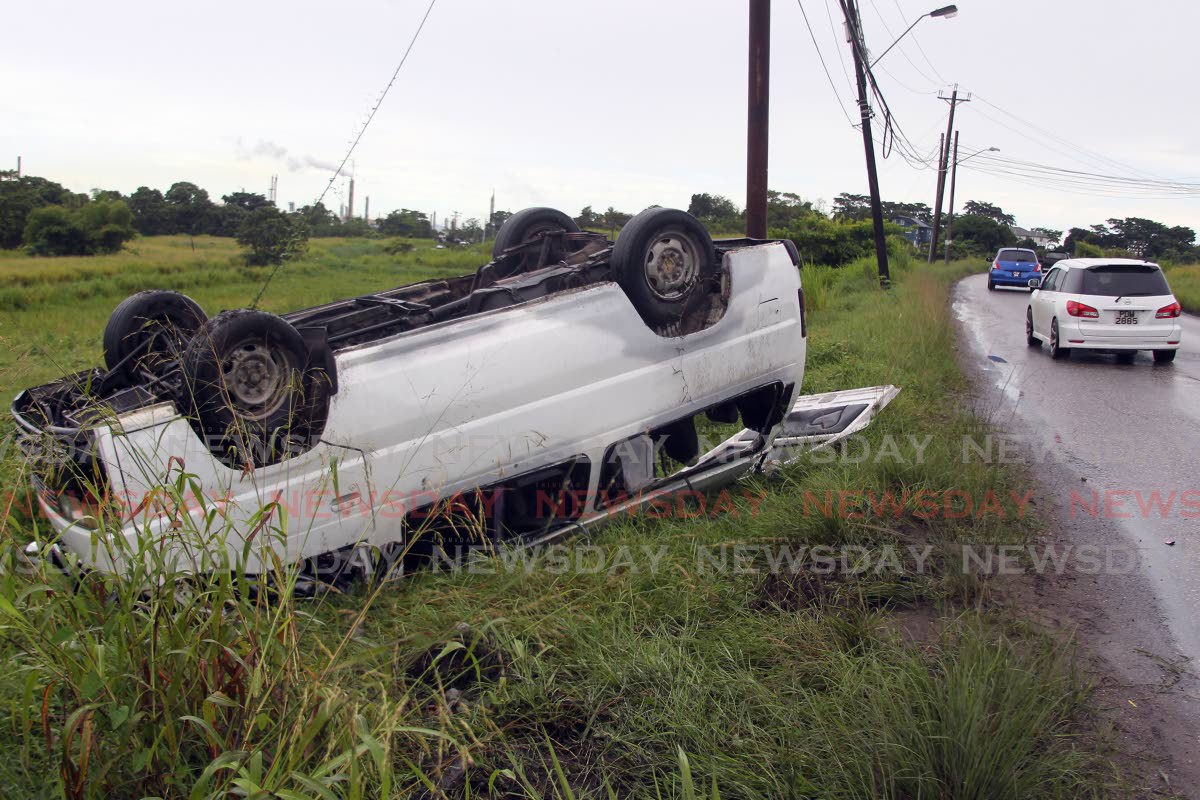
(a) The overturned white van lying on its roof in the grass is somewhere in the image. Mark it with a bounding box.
[12,207,849,582]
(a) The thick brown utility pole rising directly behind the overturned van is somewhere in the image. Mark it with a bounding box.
[746,0,770,239]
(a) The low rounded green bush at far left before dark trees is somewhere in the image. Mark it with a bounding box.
[23,200,137,255]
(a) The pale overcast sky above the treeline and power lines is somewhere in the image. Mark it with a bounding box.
[0,0,1200,235]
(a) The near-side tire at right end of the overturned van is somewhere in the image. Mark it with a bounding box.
[611,209,718,327]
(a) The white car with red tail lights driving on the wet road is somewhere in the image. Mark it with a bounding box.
[1025,258,1183,363]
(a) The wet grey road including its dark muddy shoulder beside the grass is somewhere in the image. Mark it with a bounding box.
[953,275,1200,796]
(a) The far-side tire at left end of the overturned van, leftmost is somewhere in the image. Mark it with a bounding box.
[103,289,208,380]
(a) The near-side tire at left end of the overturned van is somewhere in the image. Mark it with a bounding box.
[182,309,330,467]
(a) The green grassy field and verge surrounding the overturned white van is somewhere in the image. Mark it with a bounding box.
[0,239,1116,800]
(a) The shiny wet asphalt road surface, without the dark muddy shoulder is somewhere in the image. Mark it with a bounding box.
[953,275,1200,664]
